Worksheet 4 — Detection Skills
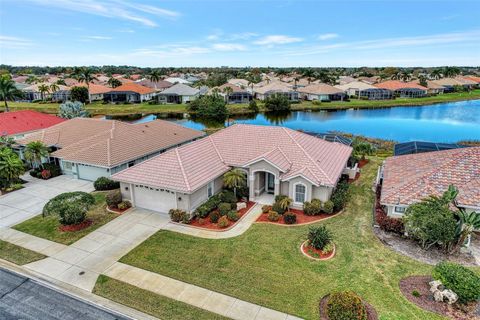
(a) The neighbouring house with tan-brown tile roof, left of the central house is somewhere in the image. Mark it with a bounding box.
[18,118,204,181]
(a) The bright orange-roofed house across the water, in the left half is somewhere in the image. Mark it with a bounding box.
[103,82,156,103]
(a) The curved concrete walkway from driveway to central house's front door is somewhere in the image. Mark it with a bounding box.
[163,203,262,239]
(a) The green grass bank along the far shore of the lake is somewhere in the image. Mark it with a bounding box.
[0,90,480,116]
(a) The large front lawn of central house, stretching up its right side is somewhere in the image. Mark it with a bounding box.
[121,159,450,320]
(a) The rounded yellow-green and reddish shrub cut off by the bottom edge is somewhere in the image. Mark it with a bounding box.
[327,291,367,320]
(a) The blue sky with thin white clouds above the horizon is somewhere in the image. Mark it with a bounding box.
[0,0,480,67]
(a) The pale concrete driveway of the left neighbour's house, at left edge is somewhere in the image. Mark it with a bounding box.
[0,173,94,228]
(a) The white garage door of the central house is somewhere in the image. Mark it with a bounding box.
[134,186,176,213]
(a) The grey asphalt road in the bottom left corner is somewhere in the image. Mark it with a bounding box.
[0,268,129,320]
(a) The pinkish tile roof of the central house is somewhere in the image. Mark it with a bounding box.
[113,124,352,193]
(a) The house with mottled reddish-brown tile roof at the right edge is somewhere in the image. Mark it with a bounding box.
[377,147,480,217]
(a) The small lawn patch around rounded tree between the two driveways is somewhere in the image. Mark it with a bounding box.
[13,192,118,245]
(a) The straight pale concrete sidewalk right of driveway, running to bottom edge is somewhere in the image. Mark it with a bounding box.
[104,262,300,320]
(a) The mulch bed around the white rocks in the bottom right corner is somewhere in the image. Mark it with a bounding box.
[400,276,480,320]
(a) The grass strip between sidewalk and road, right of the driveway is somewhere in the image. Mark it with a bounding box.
[93,275,227,320]
